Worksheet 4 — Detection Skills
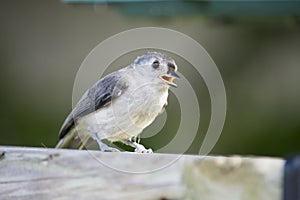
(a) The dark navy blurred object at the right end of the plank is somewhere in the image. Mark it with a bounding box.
[283,155,300,200]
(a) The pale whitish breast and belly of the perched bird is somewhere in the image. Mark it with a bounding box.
[80,86,168,141]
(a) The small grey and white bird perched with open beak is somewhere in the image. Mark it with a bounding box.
[56,51,180,153]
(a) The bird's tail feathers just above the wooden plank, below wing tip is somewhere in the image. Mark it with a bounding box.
[55,128,93,149]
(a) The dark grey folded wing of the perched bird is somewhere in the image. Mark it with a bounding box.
[59,71,128,139]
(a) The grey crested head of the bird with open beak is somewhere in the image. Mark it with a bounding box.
[130,52,179,87]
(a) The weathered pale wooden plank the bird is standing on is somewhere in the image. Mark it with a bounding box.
[0,147,284,200]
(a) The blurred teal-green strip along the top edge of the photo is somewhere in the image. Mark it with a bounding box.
[63,0,300,16]
